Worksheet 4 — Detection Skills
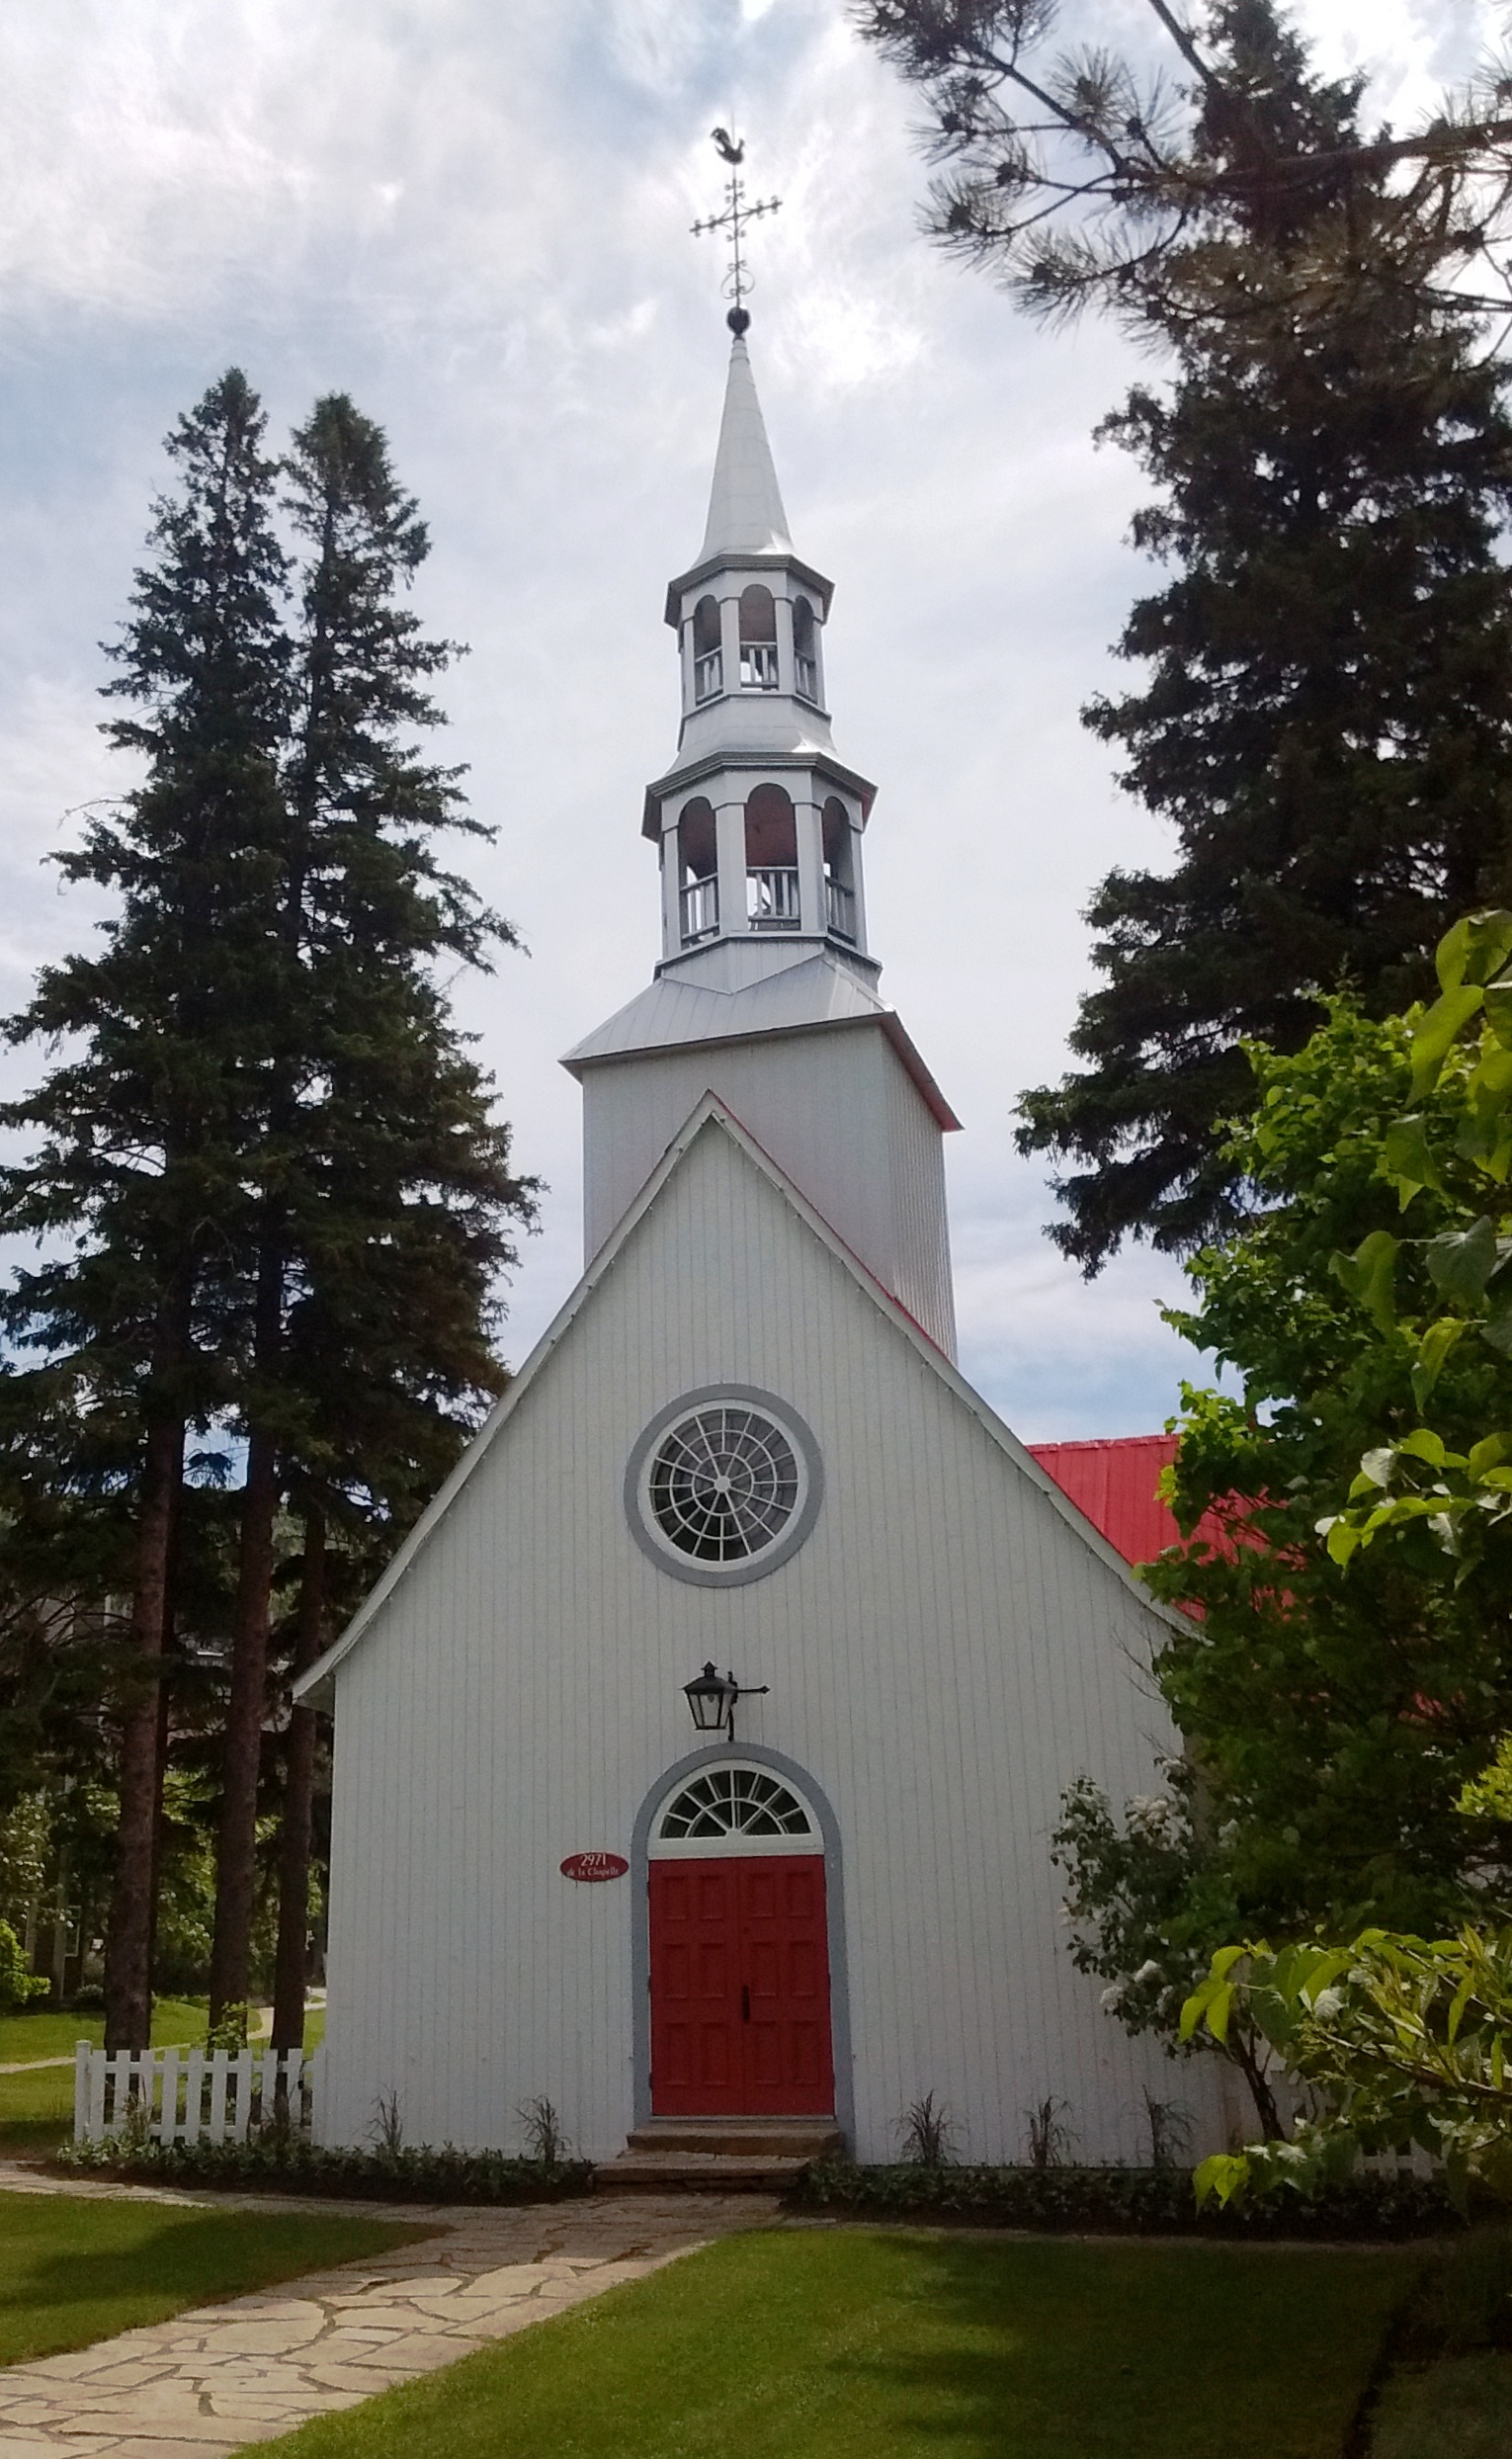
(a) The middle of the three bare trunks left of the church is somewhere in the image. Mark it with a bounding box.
[209,1431,278,2029]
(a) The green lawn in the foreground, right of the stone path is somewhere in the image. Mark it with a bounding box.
[261,2228,1423,2459]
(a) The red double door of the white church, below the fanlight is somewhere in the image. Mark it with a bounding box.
[651,1854,836,2117]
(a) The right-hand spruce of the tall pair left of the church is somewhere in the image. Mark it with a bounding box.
[211,396,534,2046]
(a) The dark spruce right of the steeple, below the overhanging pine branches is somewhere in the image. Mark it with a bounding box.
[1018,278,1512,1271]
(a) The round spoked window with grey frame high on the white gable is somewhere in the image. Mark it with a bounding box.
[625,1387,821,1586]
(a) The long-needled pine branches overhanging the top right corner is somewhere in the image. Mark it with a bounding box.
[856,0,1512,339]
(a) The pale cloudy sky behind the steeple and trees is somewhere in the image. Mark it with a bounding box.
[0,0,1502,1438]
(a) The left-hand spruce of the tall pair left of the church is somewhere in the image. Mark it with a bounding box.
[0,369,288,2049]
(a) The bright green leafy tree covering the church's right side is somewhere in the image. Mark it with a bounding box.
[1059,917,1512,2132]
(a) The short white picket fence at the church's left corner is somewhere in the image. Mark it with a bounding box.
[74,2041,324,2145]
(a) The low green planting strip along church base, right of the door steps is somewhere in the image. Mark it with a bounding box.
[787,2162,1463,2238]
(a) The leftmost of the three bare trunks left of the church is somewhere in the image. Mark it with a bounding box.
[106,1416,185,2049]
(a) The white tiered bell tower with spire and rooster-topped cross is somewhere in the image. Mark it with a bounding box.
[563,145,959,1357]
